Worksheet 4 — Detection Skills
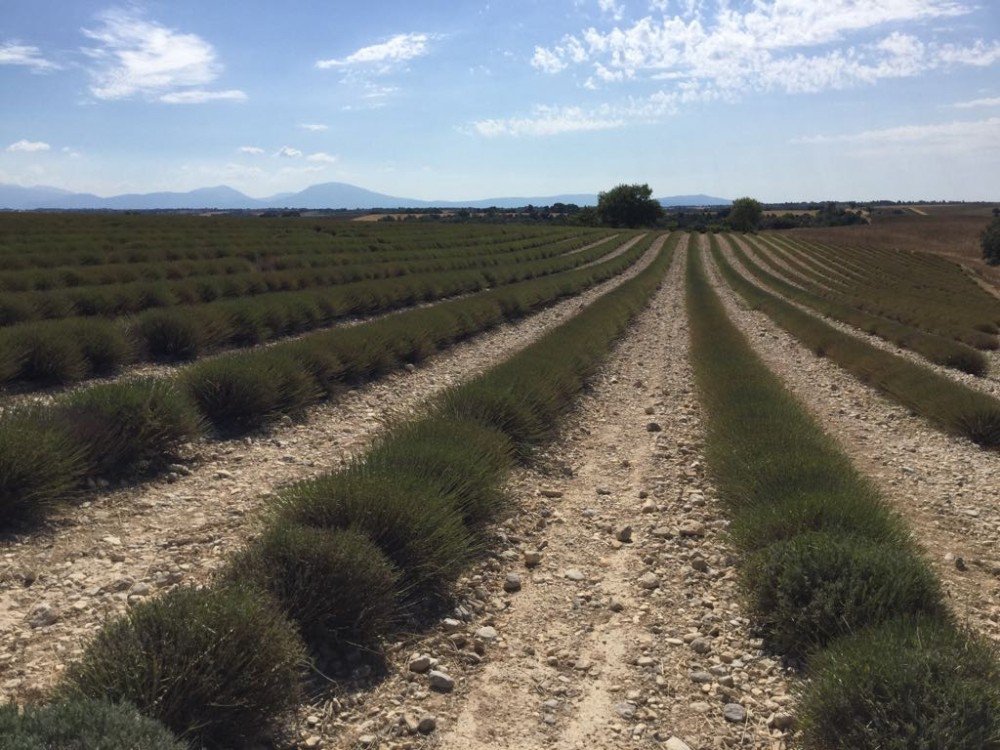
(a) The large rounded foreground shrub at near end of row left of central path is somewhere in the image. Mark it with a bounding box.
[58,587,303,747]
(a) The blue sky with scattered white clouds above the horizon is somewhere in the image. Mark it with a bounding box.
[0,0,1000,201]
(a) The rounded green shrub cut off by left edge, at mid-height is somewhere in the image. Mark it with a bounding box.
[0,408,85,529]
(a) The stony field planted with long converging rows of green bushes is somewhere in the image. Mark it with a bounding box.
[0,214,1000,750]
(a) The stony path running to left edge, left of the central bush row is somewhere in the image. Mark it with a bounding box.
[0,235,666,701]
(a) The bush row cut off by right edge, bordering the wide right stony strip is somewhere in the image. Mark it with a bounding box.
[711,236,1000,447]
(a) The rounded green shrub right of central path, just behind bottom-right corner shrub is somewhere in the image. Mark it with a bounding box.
[743,532,943,656]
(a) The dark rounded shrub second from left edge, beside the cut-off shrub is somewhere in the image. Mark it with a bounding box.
[57,378,201,477]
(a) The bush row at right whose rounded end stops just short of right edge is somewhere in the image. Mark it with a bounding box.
[729,240,989,377]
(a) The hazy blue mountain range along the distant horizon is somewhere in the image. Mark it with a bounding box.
[0,182,731,211]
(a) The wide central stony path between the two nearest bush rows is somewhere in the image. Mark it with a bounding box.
[299,238,791,750]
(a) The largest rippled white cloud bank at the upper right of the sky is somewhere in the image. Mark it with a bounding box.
[532,0,1000,93]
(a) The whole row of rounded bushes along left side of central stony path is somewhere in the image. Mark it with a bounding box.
[43,234,676,748]
